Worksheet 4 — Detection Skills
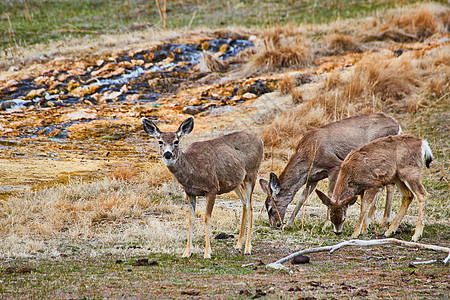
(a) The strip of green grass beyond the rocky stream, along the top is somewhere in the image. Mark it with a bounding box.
[0,0,445,51]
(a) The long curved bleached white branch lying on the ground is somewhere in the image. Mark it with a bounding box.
[266,238,450,269]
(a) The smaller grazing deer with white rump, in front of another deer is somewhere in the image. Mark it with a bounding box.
[316,135,433,242]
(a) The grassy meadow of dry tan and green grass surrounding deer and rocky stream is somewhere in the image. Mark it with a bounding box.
[0,0,450,299]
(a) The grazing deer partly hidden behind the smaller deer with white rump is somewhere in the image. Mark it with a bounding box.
[260,113,401,228]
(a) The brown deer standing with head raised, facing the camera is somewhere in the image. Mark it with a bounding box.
[142,117,263,258]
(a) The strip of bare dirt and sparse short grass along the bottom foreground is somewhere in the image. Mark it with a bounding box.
[0,236,450,299]
